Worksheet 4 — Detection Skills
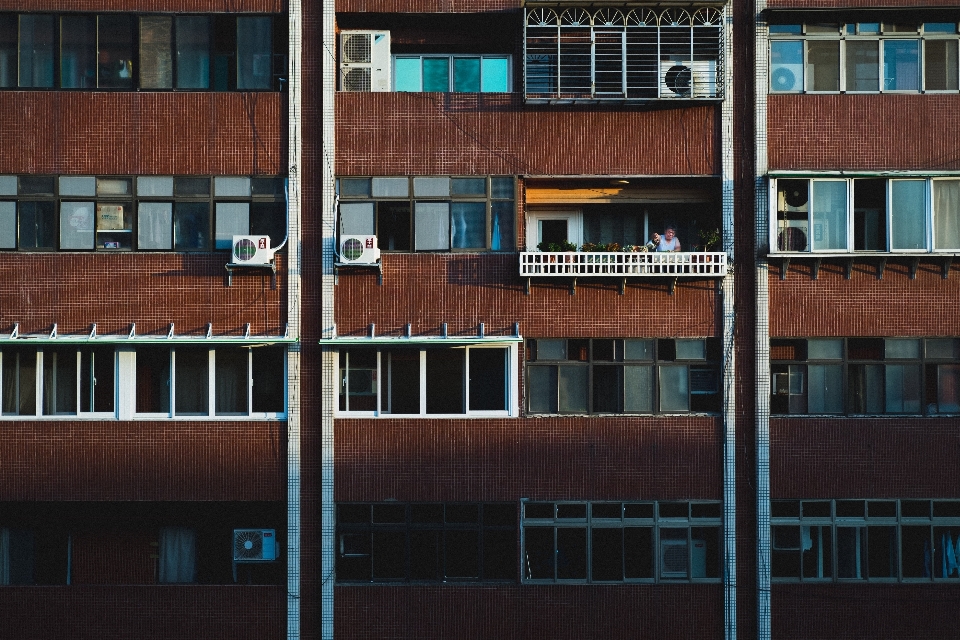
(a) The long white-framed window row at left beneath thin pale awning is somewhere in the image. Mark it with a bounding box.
[0,344,286,418]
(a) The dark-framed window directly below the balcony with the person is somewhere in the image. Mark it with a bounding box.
[526,338,719,414]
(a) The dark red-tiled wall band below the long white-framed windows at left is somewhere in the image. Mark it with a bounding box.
[0,420,286,500]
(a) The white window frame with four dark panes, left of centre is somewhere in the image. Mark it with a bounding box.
[334,342,520,419]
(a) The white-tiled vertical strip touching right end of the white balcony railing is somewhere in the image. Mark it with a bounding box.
[720,4,737,640]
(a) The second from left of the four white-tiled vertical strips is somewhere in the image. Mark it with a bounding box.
[317,0,339,640]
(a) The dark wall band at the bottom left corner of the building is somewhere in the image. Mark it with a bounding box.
[0,585,286,640]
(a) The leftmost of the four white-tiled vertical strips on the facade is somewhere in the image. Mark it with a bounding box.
[287,0,303,640]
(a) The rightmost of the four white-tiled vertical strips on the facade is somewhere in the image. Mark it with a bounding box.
[754,0,770,640]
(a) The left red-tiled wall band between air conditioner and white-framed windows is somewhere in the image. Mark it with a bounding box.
[0,251,287,335]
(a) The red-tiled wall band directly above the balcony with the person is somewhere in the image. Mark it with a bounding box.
[336,93,720,176]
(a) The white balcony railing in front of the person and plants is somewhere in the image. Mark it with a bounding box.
[520,251,727,277]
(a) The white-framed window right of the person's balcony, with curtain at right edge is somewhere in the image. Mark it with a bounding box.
[771,177,960,253]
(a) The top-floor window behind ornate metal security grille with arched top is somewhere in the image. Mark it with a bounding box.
[524,7,723,100]
